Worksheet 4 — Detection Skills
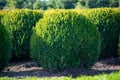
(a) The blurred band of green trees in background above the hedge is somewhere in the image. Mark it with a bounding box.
[0,0,120,10]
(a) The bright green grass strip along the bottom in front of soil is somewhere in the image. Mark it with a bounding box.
[0,71,120,80]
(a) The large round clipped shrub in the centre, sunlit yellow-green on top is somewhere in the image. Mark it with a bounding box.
[30,10,100,71]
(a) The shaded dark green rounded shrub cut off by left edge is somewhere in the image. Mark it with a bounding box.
[0,22,11,71]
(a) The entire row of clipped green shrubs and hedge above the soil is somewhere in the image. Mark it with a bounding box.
[0,8,120,71]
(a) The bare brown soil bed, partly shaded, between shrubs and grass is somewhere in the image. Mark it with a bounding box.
[0,58,120,78]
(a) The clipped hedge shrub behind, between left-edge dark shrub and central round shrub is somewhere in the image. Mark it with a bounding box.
[2,10,43,59]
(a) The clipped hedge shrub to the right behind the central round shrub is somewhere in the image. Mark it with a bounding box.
[81,8,120,59]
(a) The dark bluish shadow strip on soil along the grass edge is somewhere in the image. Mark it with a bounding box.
[0,69,118,78]
